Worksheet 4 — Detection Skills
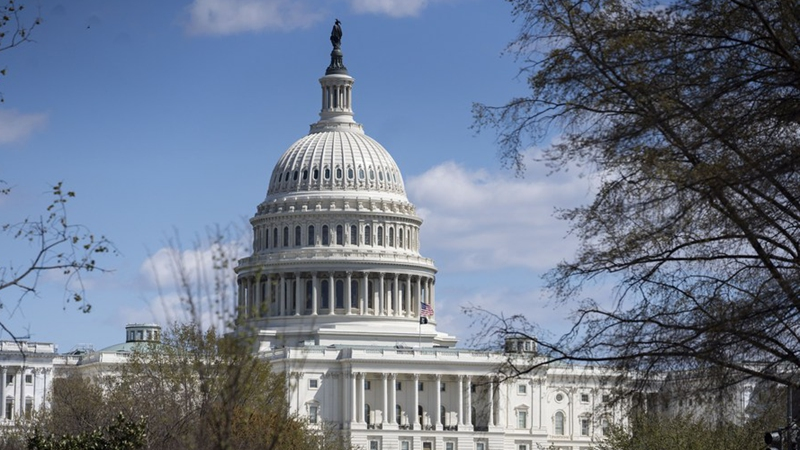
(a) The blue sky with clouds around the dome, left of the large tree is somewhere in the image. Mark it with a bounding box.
[0,0,590,351]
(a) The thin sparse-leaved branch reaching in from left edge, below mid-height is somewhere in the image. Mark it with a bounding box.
[0,181,116,339]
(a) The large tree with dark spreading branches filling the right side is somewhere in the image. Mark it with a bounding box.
[473,0,800,396]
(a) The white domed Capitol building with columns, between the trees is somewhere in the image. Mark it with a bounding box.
[231,23,620,450]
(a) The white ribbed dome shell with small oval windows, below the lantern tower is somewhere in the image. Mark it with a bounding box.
[267,130,406,200]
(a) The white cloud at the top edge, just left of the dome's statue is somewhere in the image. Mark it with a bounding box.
[186,0,325,35]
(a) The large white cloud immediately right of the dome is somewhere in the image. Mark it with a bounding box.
[406,161,590,271]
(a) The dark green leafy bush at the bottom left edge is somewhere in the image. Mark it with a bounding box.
[27,414,146,450]
